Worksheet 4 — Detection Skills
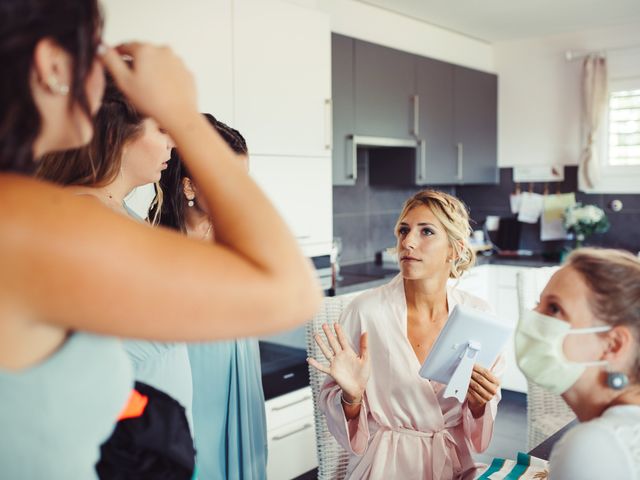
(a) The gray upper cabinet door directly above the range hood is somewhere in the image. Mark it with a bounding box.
[354,40,415,139]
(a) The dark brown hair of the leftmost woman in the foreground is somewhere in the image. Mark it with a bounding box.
[0,0,102,173]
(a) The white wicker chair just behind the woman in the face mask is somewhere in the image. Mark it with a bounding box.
[517,267,576,450]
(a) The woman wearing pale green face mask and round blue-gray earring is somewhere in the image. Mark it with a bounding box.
[516,248,640,480]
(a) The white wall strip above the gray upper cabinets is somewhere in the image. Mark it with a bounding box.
[312,0,495,72]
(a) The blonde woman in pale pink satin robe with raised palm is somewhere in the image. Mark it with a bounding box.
[309,190,504,480]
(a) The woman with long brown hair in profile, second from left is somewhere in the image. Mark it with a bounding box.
[36,76,192,432]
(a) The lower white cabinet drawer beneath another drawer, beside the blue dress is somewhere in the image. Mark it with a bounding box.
[267,415,318,480]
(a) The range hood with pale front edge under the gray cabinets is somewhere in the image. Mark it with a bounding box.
[347,135,427,186]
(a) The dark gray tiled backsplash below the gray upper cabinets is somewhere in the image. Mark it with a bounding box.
[333,162,640,265]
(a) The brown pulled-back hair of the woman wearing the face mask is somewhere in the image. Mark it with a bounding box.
[566,248,640,381]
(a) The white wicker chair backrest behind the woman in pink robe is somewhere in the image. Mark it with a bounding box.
[306,295,354,480]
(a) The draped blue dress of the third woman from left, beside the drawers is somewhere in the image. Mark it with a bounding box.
[188,339,267,480]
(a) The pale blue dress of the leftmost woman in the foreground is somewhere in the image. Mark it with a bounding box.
[0,333,133,480]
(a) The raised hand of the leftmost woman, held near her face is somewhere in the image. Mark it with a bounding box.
[102,43,198,128]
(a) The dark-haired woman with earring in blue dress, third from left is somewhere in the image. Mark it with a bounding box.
[151,114,267,480]
